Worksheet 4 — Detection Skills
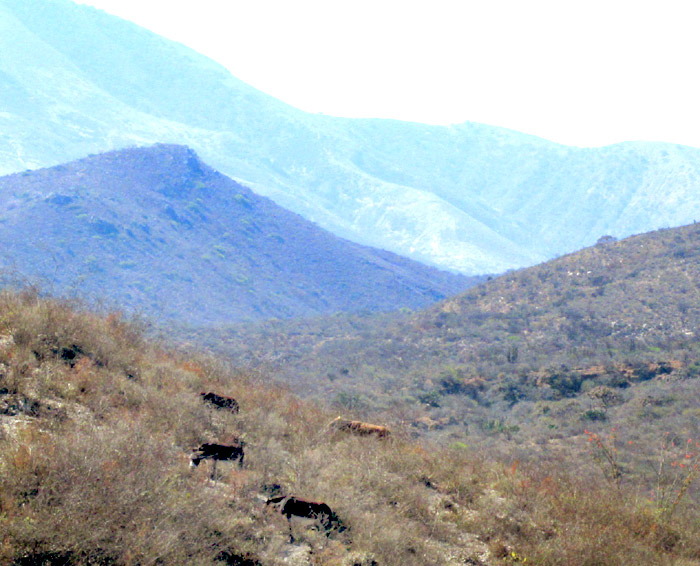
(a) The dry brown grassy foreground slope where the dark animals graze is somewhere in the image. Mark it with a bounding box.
[0,292,700,566]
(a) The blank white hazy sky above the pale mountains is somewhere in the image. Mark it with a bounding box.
[72,0,700,147]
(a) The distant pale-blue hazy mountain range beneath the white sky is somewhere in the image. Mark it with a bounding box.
[0,0,700,274]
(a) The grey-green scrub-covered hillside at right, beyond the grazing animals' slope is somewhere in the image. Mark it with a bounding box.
[206,224,700,466]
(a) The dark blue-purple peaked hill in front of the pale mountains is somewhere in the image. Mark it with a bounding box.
[0,145,468,325]
